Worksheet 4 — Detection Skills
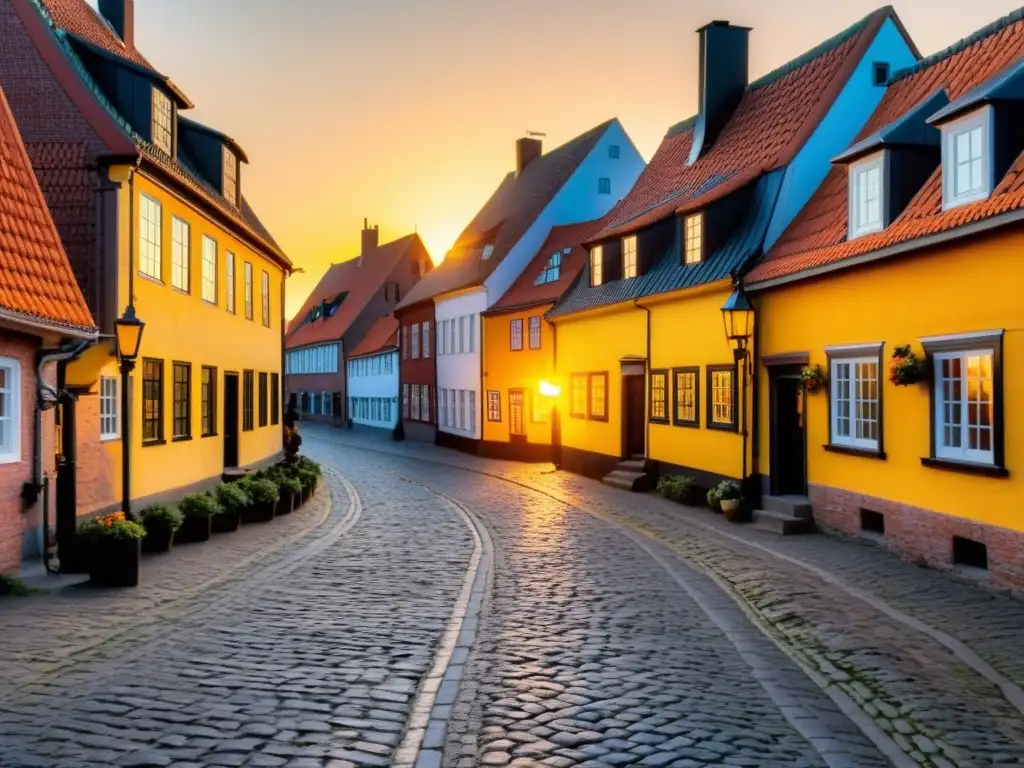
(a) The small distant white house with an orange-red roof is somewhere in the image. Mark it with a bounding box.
[345,317,399,429]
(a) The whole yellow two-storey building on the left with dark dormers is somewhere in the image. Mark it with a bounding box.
[0,0,291,536]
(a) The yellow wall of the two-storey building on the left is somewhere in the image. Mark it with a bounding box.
[68,168,286,514]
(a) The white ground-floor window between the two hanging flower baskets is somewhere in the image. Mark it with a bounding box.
[825,344,882,452]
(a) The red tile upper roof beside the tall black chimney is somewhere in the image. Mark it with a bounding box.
[595,7,902,240]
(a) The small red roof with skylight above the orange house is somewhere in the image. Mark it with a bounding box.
[492,217,607,312]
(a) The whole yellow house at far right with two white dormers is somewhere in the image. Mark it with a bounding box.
[746,14,1024,591]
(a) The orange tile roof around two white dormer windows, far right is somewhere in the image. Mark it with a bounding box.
[746,11,1024,284]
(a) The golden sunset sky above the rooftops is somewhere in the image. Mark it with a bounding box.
[92,0,1017,315]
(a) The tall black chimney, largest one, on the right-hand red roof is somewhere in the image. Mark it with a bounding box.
[689,22,751,165]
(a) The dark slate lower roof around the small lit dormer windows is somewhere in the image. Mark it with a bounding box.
[547,169,785,317]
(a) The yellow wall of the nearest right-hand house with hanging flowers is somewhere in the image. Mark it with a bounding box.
[755,230,1024,531]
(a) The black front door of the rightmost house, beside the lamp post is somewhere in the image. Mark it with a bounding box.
[771,375,807,496]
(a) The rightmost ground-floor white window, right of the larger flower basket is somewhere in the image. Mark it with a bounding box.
[922,332,1006,468]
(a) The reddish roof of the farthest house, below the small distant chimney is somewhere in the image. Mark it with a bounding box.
[286,234,421,349]
